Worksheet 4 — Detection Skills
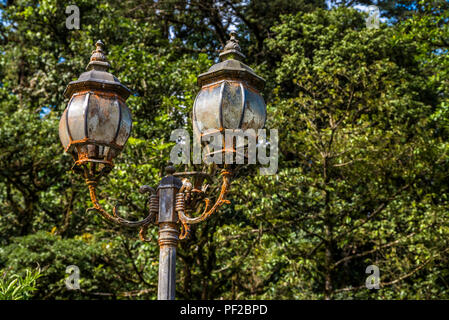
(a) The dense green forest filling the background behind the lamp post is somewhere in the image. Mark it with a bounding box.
[0,0,449,299]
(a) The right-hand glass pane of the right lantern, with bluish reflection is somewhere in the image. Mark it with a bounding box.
[241,88,267,130]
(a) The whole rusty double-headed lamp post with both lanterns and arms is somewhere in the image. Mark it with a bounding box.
[59,33,266,300]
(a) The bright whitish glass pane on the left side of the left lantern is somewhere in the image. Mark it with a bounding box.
[67,94,88,140]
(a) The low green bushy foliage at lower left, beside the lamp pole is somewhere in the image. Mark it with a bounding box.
[0,231,157,299]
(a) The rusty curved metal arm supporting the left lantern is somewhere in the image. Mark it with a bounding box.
[86,181,156,229]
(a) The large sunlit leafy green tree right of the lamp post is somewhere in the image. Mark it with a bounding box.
[260,8,448,298]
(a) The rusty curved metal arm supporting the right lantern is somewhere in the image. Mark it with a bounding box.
[176,170,231,240]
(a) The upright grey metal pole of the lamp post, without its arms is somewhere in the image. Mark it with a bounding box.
[157,166,182,300]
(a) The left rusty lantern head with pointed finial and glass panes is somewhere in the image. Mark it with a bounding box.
[59,40,132,178]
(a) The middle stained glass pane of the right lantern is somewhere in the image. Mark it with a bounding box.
[221,82,243,129]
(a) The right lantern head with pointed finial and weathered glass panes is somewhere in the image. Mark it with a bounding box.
[193,32,267,164]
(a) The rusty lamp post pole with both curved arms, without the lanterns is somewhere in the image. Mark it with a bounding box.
[82,162,231,300]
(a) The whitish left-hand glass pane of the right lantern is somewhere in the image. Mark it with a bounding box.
[193,83,223,132]
